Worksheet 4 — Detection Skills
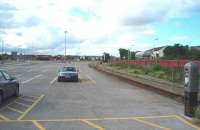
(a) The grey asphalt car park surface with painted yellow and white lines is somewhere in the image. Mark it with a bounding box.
[0,61,200,130]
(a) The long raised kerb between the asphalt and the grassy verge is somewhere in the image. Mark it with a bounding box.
[89,64,184,103]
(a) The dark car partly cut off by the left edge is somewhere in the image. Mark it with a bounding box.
[0,70,19,104]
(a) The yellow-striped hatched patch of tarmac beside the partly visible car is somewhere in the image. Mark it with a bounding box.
[0,95,44,121]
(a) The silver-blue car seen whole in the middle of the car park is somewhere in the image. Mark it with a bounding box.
[58,67,78,82]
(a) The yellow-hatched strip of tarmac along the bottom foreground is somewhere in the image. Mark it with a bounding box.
[0,115,200,130]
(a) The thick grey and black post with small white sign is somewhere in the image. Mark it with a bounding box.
[184,62,199,117]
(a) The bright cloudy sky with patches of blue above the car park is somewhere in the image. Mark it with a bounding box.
[0,0,200,56]
